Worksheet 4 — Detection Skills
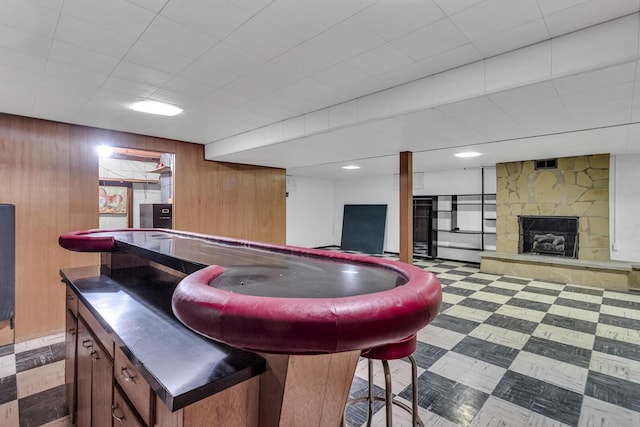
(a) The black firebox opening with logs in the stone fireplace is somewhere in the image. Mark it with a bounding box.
[518,215,578,258]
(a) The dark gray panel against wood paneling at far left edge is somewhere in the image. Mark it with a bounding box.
[0,204,16,320]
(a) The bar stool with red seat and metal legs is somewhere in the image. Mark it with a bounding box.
[342,334,424,427]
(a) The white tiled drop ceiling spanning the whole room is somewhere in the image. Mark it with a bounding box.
[0,0,640,178]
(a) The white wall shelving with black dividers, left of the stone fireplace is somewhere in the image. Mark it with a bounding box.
[436,194,496,262]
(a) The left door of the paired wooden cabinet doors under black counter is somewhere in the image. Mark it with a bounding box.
[76,318,95,427]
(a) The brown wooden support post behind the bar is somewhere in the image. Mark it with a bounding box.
[400,151,413,264]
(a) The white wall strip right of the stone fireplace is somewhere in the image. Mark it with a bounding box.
[609,154,640,262]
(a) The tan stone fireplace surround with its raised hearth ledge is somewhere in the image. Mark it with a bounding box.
[480,154,640,289]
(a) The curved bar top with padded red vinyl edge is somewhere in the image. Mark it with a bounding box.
[60,229,442,354]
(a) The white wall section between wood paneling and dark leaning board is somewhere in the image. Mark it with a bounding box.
[287,176,336,248]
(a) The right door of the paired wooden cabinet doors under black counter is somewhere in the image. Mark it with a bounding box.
[91,343,113,427]
